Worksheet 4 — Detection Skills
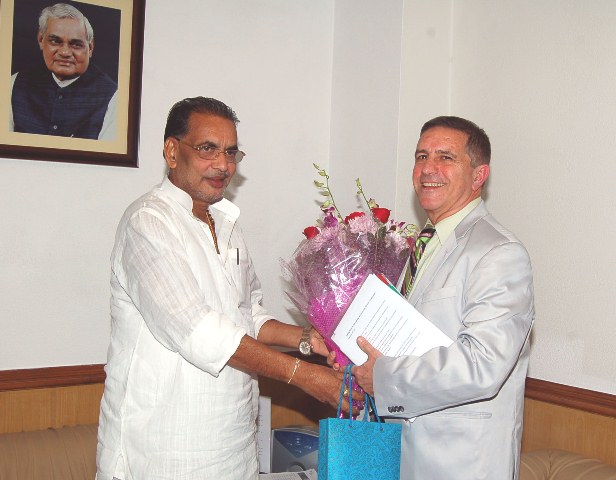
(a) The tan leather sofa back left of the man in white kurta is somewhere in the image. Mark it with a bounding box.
[0,425,98,480]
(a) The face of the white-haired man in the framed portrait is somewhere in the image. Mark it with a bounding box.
[38,18,94,80]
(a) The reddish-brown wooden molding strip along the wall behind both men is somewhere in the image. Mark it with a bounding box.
[0,364,616,418]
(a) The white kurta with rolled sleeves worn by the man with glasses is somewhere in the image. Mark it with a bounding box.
[97,179,271,480]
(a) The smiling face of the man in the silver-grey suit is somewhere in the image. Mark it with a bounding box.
[413,127,490,225]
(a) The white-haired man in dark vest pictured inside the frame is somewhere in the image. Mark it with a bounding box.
[9,3,118,141]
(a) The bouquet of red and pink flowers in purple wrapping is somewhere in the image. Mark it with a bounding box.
[282,164,419,366]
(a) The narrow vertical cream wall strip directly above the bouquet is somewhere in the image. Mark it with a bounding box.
[330,0,403,214]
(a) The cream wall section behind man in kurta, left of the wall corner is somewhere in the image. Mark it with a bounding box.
[0,0,334,369]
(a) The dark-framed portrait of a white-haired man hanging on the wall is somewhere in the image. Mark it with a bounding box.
[0,0,145,167]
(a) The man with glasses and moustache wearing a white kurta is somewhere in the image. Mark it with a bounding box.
[97,97,348,480]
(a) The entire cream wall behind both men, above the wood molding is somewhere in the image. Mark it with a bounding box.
[0,0,616,393]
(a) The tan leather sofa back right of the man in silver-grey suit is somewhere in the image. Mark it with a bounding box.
[520,450,616,480]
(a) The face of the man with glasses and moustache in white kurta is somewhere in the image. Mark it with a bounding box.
[164,113,237,221]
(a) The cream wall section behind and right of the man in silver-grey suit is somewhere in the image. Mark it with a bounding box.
[397,0,616,394]
